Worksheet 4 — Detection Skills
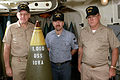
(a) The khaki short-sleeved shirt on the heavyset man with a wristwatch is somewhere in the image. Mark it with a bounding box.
[79,25,120,66]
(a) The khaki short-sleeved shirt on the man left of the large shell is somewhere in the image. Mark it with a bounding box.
[3,22,34,57]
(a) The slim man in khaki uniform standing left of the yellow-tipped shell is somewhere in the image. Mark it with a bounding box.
[3,4,34,80]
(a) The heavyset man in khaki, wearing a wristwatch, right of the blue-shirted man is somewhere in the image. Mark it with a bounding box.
[78,6,120,80]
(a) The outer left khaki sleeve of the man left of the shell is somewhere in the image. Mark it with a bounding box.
[3,26,12,44]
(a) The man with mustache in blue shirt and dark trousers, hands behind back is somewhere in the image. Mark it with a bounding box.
[46,12,78,80]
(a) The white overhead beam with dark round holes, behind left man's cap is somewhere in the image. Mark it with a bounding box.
[0,0,58,13]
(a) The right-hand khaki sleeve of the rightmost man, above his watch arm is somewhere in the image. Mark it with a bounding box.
[108,29,120,49]
